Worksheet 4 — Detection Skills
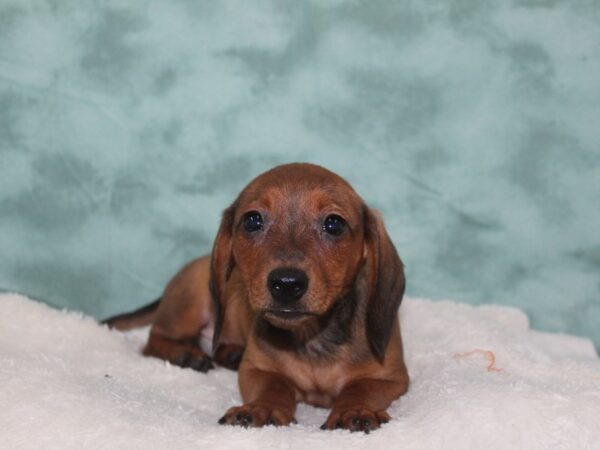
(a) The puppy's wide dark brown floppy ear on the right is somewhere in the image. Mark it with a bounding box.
[365,209,406,360]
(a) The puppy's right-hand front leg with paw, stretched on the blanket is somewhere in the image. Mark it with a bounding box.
[321,377,408,433]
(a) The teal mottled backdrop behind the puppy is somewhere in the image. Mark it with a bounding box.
[0,0,600,345]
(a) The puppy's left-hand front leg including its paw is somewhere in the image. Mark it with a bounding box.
[219,369,296,427]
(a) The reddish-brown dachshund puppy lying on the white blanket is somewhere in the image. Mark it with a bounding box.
[106,164,409,432]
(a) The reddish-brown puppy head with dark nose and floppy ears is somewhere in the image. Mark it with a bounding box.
[211,164,404,354]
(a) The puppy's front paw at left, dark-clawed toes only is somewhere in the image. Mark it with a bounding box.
[219,403,297,428]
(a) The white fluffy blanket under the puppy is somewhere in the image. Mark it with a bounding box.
[0,295,600,450]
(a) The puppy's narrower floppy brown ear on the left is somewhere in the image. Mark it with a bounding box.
[209,203,236,351]
